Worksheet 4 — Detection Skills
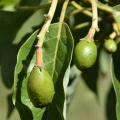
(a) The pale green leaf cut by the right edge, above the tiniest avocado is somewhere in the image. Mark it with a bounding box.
[113,4,120,23]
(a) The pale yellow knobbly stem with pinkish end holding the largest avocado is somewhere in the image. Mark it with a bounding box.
[36,0,58,68]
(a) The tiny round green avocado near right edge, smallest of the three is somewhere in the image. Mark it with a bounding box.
[104,39,117,53]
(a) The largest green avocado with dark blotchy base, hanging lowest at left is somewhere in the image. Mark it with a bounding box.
[27,66,55,108]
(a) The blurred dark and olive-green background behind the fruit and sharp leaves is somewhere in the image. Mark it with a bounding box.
[0,0,119,120]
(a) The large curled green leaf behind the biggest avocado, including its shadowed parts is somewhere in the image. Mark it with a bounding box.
[13,23,73,120]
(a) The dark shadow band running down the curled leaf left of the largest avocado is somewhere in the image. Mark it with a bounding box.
[16,40,35,120]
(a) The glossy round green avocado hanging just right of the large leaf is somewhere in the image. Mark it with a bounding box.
[74,39,97,70]
